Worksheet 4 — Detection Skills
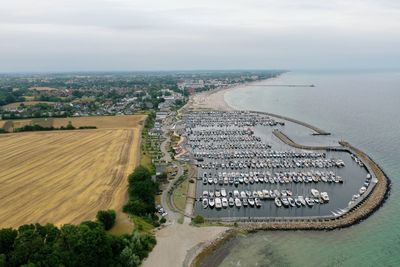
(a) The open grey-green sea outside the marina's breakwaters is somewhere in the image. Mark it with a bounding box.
[209,72,400,266]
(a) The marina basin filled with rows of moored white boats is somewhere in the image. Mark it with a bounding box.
[184,111,377,220]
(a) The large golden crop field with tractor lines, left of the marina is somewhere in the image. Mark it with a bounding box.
[0,116,145,228]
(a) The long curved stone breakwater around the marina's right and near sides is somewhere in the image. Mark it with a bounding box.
[190,125,391,267]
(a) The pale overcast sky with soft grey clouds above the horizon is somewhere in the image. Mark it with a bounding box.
[0,0,400,72]
